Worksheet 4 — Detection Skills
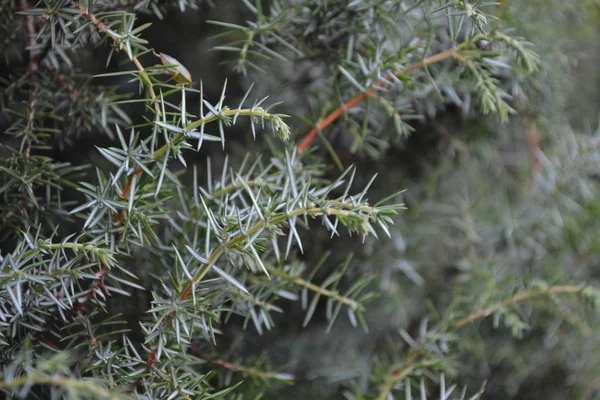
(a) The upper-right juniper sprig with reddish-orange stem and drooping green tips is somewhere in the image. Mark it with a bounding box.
[215,0,538,158]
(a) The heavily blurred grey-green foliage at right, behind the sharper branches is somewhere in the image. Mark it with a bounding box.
[217,0,600,400]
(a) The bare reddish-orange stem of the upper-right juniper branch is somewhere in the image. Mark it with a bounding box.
[298,44,465,152]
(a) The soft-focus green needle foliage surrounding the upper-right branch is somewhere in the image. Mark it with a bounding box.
[213,0,538,157]
